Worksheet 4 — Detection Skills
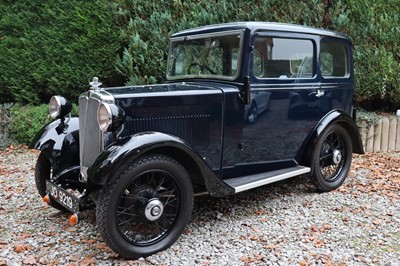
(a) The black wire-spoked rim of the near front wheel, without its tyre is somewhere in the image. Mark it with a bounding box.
[117,170,182,246]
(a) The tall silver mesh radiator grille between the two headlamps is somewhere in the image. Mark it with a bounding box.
[79,95,103,171]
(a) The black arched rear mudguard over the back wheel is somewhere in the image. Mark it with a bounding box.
[296,110,364,166]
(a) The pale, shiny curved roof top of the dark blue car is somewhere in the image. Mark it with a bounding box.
[171,21,351,42]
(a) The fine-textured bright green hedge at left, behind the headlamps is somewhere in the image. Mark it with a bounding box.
[0,0,122,104]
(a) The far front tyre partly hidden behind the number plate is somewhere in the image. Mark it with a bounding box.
[35,153,67,212]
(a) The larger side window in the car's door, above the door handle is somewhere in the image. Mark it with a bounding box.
[253,37,315,79]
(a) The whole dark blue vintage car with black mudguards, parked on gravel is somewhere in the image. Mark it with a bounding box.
[31,22,363,258]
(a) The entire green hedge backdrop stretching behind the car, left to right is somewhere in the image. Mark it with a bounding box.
[0,0,400,143]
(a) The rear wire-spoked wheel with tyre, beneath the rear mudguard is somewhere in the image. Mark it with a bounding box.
[312,124,353,192]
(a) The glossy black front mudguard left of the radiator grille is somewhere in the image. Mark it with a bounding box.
[29,117,80,179]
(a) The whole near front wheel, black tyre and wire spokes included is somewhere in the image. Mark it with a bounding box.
[96,155,193,259]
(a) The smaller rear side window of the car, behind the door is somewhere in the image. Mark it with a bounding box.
[320,41,349,78]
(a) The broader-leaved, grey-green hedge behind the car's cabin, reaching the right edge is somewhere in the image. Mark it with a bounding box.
[116,0,400,110]
